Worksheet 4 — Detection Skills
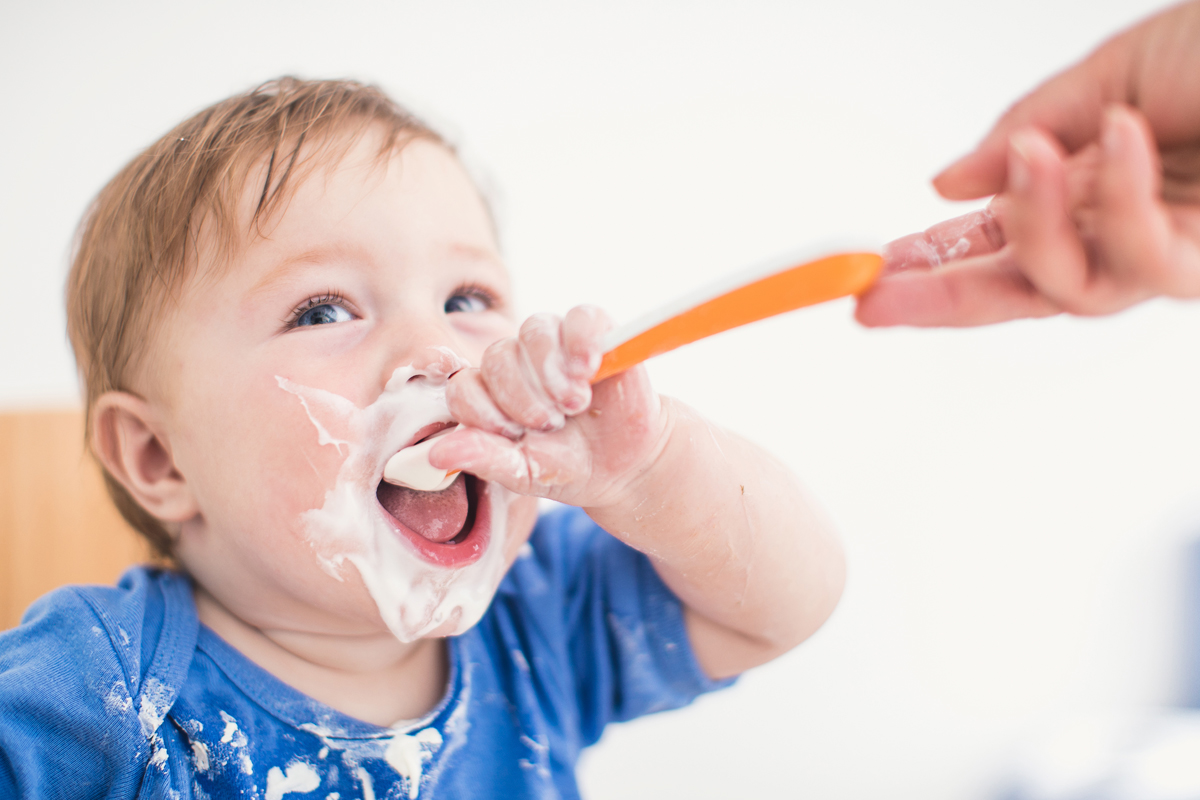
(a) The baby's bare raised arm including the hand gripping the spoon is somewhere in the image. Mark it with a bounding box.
[431,307,845,678]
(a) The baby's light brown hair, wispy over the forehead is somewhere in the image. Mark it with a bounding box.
[66,78,446,558]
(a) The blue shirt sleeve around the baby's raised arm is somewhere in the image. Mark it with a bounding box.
[539,509,733,745]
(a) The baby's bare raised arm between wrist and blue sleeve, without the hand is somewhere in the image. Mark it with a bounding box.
[586,398,845,678]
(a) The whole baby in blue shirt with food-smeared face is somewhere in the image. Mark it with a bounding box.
[0,79,844,800]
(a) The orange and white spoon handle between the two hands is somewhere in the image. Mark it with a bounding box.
[592,252,883,384]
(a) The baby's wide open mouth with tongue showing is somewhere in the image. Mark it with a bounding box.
[376,434,491,567]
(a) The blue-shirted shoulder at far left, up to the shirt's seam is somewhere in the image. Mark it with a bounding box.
[0,567,198,796]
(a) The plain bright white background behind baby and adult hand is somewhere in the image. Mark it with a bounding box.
[0,0,1200,800]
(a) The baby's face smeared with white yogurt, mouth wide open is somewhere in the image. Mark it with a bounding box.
[154,137,536,640]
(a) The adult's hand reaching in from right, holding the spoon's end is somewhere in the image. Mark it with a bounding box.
[856,1,1200,326]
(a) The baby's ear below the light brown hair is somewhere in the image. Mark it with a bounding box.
[91,392,199,522]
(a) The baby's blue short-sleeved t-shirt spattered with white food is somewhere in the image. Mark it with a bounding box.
[0,509,728,800]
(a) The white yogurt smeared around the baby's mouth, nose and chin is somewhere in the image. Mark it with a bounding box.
[276,350,512,642]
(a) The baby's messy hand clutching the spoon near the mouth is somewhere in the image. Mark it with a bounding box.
[430,306,670,507]
